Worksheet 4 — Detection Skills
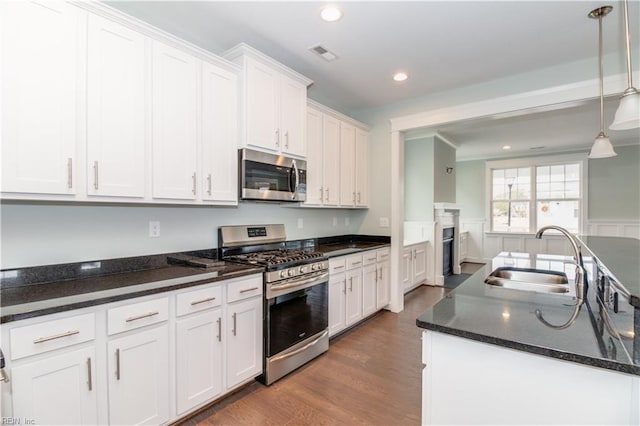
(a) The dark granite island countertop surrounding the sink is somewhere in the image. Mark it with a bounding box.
[416,253,640,375]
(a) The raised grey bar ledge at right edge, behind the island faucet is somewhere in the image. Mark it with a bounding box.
[579,236,640,308]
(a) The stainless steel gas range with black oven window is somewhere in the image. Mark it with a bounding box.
[218,225,329,385]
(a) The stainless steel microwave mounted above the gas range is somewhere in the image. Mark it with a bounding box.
[238,148,307,202]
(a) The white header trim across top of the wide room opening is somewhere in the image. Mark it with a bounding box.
[390,73,638,131]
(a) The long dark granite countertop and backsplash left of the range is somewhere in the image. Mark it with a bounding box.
[0,251,263,323]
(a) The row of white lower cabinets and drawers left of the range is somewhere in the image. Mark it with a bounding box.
[0,274,263,425]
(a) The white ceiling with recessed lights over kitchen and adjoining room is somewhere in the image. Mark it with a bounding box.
[108,0,640,159]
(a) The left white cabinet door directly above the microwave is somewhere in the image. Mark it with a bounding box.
[245,59,281,151]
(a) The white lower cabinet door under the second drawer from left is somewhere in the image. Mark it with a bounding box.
[107,324,169,425]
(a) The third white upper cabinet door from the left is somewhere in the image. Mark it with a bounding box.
[152,41,200,199]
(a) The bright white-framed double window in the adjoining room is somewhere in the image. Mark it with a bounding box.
[487,158,583,232]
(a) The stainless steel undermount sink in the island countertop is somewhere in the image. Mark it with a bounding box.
[484,266,570,294]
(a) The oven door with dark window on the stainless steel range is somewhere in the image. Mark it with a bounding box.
[265,273,329,358]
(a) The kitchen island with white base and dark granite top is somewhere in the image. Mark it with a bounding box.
[416,253,640,424]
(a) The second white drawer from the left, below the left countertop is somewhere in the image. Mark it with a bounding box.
[107,297,169,335]
